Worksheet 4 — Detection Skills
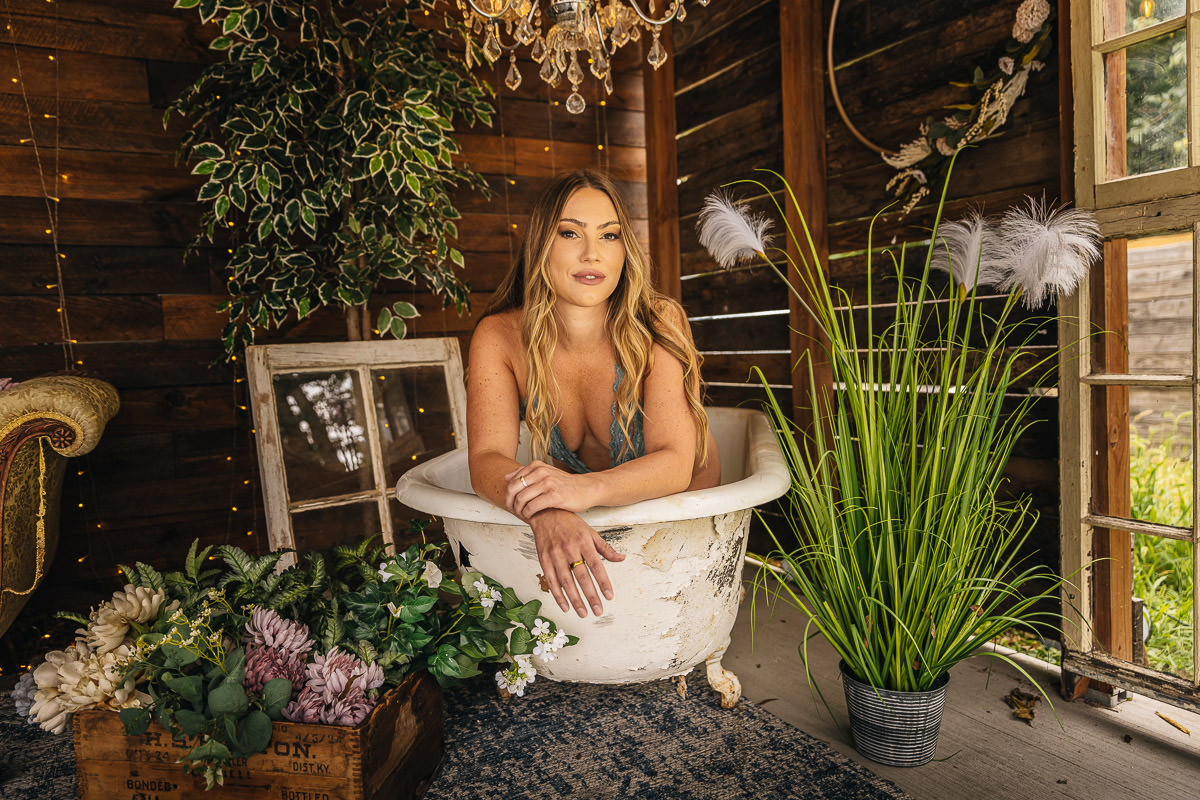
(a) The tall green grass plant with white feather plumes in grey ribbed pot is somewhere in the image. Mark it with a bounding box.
[700,175,1099,766]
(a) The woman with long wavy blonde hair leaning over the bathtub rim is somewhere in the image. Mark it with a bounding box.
[467,172,721,616]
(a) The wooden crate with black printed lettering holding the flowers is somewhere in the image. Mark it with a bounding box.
[74,675,444,800]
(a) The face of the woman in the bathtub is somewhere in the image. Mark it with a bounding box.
[548,187,625,307]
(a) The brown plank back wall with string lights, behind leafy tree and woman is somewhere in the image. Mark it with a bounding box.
[0,0,647,633]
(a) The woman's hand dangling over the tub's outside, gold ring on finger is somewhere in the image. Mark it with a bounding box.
[529,509,625,616]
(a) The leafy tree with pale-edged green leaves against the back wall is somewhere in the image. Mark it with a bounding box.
[163,0,492,356]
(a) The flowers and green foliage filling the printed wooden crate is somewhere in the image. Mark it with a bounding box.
[23,540,578,788]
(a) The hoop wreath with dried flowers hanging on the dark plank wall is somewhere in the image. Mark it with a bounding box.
[826,0,1055,217]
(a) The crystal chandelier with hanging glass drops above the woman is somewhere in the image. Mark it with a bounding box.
[457,0,708,114]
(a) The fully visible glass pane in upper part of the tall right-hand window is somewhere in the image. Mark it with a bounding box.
[1104,29,1188,179]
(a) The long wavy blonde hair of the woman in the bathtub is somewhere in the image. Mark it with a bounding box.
[484,169,708,464]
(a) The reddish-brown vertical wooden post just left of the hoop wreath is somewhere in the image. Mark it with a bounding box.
[779,0,832,428]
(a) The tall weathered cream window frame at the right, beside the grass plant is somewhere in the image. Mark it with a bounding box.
[1058,0,1200,708]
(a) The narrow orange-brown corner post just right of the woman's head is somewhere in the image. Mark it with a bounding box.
[642,25,683,300]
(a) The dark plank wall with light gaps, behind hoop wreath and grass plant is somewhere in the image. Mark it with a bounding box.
[674,0,1069,575]
